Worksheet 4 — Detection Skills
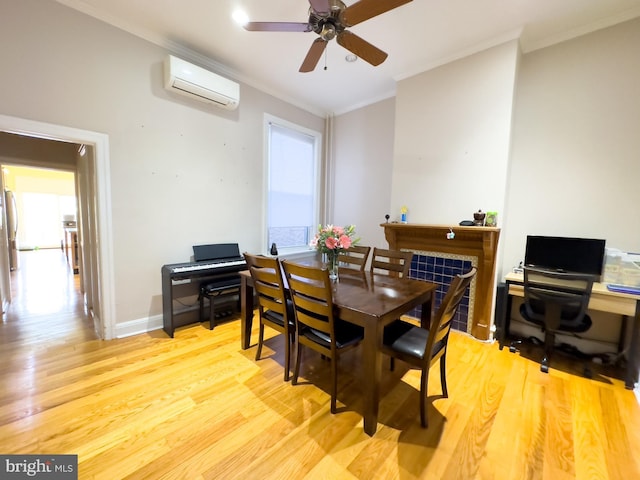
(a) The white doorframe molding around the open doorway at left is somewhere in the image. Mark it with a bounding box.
[0,114,115,340]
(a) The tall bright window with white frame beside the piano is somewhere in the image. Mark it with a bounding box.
[265,116,321,253]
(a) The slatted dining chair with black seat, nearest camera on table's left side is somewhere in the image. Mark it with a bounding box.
[282,260,364,413]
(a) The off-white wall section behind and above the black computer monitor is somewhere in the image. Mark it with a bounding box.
[503,19,640,273]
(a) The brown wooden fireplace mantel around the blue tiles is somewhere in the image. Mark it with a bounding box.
[380,223,500,340]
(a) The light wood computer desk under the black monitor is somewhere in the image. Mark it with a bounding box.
[496,273,640,389]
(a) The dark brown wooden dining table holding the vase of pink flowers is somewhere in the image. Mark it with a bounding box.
[240,268,437,435]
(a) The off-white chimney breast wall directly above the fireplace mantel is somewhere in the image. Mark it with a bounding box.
[390,41,519,225]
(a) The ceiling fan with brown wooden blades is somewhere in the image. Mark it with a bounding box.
[244,0,412,72]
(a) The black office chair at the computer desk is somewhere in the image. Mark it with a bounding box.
[520,267,594,376]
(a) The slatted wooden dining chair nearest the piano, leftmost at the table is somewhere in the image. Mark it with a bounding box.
[244,253,295,382]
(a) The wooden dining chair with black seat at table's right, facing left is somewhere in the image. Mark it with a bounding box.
[382,267,476,428]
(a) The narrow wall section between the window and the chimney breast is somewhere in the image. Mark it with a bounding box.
[329,98,395,247]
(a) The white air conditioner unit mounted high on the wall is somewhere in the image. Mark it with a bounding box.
[164,55,240,110]
